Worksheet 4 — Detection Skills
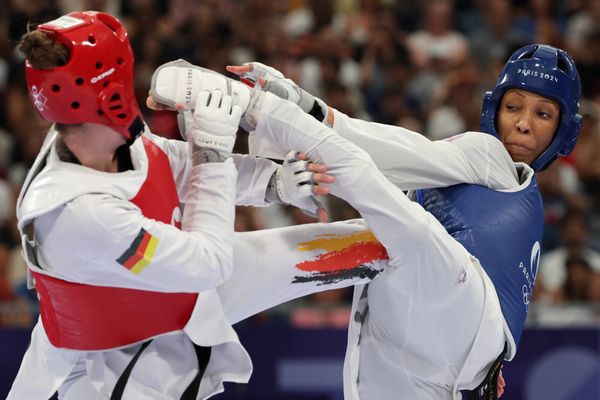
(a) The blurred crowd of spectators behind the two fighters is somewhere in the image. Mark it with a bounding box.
[0,0,600,328]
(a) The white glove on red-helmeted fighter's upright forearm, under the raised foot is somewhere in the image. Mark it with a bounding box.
[179,90,241,165]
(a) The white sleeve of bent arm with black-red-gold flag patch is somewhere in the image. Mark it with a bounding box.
[35,161,236,292]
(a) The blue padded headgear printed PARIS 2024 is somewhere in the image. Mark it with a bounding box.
[480,44,581,171]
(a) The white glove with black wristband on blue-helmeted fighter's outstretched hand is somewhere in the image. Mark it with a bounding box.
[240,62,333,128]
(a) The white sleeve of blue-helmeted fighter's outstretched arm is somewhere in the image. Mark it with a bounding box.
[333,111,518,190]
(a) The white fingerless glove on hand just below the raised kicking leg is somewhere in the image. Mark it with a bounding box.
[275,151,325,217]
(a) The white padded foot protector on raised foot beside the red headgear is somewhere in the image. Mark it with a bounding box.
[150,59,252,115]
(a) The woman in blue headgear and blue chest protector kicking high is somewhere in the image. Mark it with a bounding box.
[149,45,580,399]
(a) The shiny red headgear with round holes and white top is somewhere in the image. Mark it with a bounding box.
[25,11,144,143]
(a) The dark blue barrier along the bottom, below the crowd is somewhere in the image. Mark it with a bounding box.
[0,323,600,400]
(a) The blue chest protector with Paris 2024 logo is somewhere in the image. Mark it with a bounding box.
[416,177,544,350]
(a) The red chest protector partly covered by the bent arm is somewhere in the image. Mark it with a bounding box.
[33,137,198,350]
